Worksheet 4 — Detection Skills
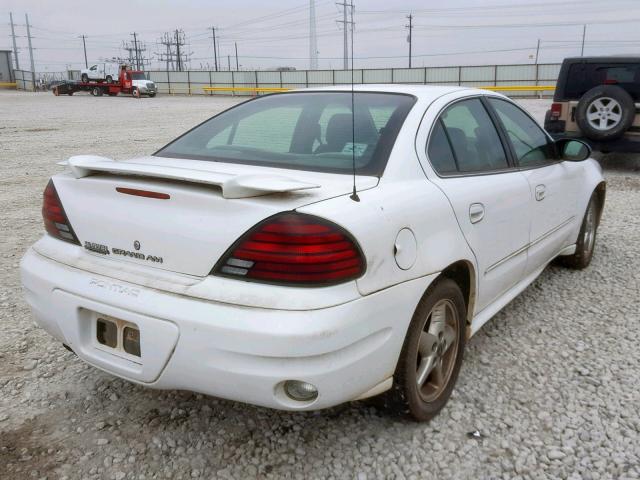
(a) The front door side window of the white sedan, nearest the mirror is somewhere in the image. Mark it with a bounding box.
[489,98,556,167]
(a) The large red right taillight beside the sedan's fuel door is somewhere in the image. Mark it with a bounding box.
[211,212,365,285]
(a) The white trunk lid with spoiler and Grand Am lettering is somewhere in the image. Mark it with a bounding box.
[53,157,378,276]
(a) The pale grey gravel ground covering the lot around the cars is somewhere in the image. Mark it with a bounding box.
[0,92,640,480]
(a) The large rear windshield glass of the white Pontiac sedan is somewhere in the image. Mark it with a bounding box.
[155,92,415,176]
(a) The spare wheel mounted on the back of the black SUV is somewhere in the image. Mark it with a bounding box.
[576,85,636,141]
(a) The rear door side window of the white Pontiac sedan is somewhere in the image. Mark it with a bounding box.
[440,98,509,173]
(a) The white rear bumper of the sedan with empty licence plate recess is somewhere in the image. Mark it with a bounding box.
[20,249,435,410]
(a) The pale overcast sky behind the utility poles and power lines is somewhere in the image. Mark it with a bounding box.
[0,0,640,72]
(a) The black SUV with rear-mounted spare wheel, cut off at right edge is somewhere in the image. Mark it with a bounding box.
[544,56,640,152]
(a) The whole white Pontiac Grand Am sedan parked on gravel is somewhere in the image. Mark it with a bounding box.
[21,85,605,420]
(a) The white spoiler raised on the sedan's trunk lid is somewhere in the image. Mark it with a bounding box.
[59,155,320,198]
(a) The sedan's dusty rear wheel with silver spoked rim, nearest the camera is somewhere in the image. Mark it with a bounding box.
[389,279,466,421]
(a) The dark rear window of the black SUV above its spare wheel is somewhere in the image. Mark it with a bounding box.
[564,63,640,100]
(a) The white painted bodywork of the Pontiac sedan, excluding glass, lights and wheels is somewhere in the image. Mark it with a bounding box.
[21,85,603,410]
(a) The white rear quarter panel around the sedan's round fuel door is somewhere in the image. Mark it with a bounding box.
[298,96,475,295]
